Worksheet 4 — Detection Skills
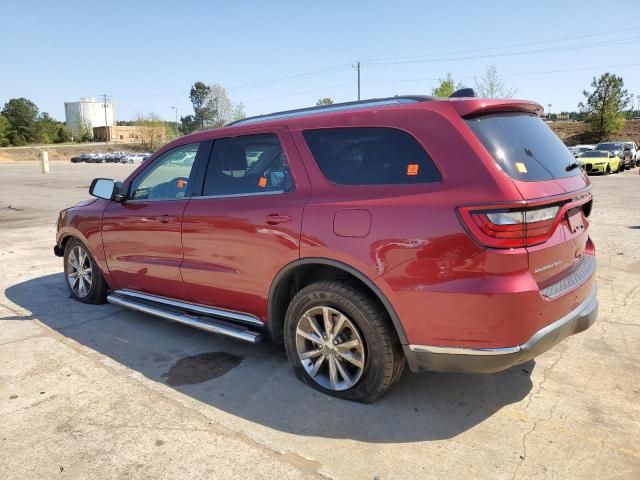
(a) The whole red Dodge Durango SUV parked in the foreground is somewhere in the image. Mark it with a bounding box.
[55,96,597,402]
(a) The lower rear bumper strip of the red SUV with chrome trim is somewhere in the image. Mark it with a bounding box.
[405,287,598,373]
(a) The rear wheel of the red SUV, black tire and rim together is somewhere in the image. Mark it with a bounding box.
[284,280,405,403]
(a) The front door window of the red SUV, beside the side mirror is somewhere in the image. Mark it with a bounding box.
[129,143,200,200]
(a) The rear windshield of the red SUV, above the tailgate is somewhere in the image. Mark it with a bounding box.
[466,113,582,182]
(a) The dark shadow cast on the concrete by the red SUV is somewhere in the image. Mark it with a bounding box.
[5,273,535,443]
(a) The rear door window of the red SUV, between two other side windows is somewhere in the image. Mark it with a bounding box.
[202,133,293,196]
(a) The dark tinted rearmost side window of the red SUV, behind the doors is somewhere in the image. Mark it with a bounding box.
[303,127,442,185]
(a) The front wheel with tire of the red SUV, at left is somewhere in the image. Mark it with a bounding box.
[64,238,107,305]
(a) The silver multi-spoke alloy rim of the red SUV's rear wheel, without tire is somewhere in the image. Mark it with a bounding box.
[296,306,366,391]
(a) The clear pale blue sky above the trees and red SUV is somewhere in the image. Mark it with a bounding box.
[0,0,640,120]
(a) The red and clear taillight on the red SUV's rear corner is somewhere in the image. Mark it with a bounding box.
[459,205,560,248]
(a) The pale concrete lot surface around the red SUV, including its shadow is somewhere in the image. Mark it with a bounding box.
[0,162,640,479]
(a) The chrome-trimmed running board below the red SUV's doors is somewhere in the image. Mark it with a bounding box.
[107,290,262,343]
